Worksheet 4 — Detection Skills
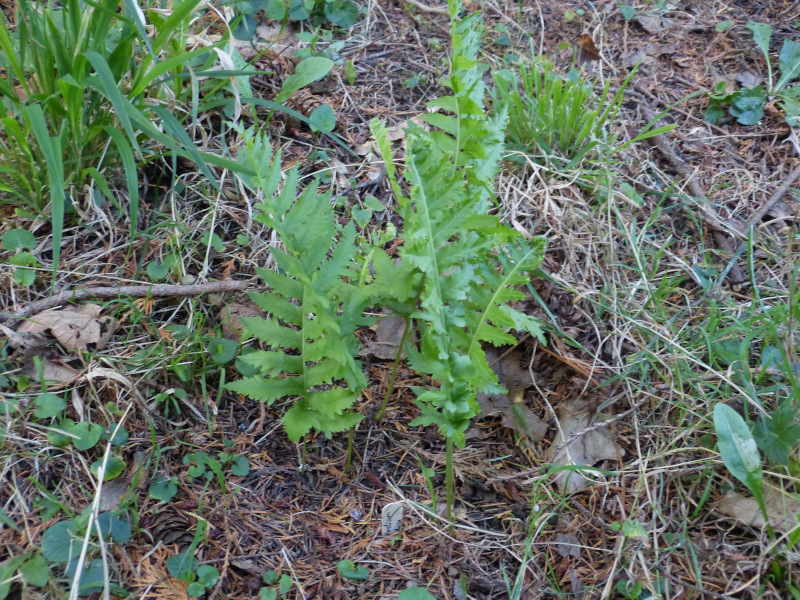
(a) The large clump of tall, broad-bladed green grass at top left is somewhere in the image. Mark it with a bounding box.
[0,0,234,276]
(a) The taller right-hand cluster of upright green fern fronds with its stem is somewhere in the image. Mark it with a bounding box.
[372,0,545,518]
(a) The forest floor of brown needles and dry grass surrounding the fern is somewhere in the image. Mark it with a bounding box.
[0,0,800,600]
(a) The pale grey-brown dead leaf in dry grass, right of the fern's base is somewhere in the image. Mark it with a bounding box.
[547,400,625,494]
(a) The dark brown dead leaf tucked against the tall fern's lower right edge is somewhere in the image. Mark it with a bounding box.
[477,346,548,441]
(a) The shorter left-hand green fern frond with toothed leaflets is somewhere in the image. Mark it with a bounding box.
[227,132,371,441]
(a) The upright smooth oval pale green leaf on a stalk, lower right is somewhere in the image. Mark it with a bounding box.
[714,402,769,520]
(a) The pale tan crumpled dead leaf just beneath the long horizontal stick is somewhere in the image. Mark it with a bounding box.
[17,304,117,352]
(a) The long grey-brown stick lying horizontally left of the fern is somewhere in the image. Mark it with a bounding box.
[0,279,250,323]
